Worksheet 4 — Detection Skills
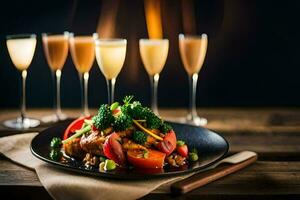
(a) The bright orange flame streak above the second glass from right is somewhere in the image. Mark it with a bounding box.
[144,0,163,39]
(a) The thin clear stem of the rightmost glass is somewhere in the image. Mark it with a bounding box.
[189,73,198,119]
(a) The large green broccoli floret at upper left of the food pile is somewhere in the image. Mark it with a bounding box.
[93,104,114,130]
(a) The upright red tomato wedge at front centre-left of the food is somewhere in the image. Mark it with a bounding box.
[103,133,126,165]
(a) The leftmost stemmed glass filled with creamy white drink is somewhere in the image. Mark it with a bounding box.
[4,34,40,129]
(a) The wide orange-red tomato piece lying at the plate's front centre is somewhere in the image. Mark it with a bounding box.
[127,149,166,169]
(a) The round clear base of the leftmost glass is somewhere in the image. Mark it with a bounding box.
[3,118,40,129]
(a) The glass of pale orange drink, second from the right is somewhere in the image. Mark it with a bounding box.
[139,39,169,114]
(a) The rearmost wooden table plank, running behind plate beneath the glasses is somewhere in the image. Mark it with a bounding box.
[0,108,300,134]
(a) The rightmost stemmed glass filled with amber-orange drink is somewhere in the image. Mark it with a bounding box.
[179,33,208,126]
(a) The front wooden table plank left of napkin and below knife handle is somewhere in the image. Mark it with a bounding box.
[0,156,300,197]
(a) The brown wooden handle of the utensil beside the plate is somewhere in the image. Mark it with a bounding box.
[171,156,257,194]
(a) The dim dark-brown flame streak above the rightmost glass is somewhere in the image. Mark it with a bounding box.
[181,0,196,35]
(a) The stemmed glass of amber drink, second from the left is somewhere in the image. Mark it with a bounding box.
[42,32,69,122]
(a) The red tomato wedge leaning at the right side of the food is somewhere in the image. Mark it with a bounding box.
[157,130,177,156]
